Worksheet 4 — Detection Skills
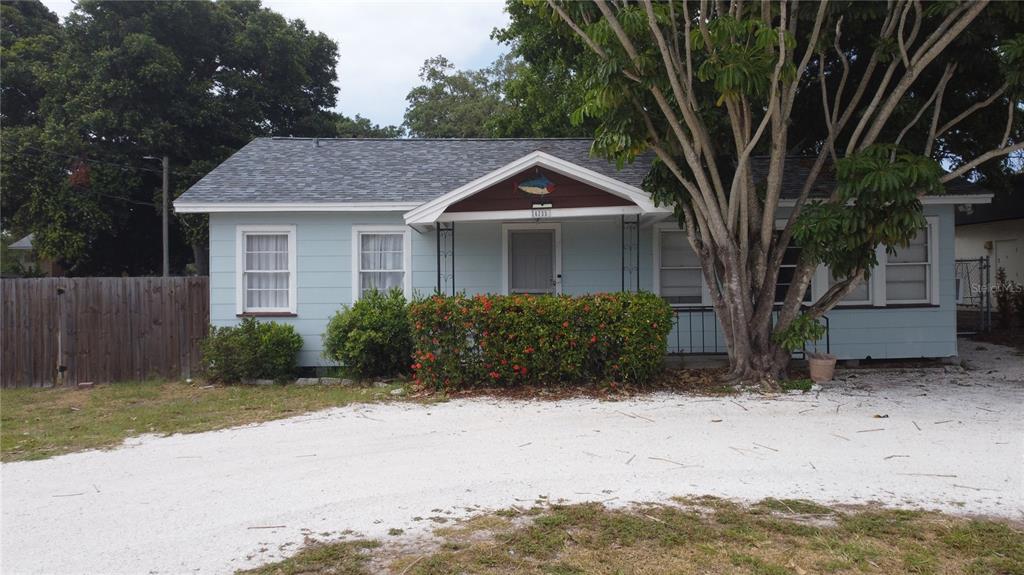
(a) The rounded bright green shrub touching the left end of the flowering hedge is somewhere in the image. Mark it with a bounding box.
[324,289,413,378]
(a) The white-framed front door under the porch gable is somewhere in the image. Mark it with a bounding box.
[505,226,560,294]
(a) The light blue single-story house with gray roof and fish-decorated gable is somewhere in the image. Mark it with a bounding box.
[175,138,990,365]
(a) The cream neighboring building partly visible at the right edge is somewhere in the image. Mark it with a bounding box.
[955,176,1024,285]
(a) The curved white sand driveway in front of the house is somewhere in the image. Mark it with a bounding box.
[0,344,1024,574]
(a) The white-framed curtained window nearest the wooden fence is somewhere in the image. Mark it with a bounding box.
[236,226,296,314]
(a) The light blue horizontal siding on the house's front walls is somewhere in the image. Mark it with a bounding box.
[210,206,956,365]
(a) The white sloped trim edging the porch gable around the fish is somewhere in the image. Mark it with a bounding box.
[404,150,662,225]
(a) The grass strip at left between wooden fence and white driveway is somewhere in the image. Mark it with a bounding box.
[0,382,399,461]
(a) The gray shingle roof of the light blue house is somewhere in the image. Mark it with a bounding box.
[178,138,650,204]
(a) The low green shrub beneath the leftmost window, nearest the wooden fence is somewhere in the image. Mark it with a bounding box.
[201,317,302,384]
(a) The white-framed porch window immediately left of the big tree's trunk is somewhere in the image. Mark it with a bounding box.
[655,229,703,305]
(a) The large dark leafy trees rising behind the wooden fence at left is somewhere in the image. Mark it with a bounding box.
[0,0,338,274]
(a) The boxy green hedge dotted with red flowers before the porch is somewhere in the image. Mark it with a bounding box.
[410,293,672,389]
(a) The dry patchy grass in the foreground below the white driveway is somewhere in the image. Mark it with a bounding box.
[245,498,1024,575]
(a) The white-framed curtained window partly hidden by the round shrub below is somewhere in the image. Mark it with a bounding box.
[352,226,412,299]
